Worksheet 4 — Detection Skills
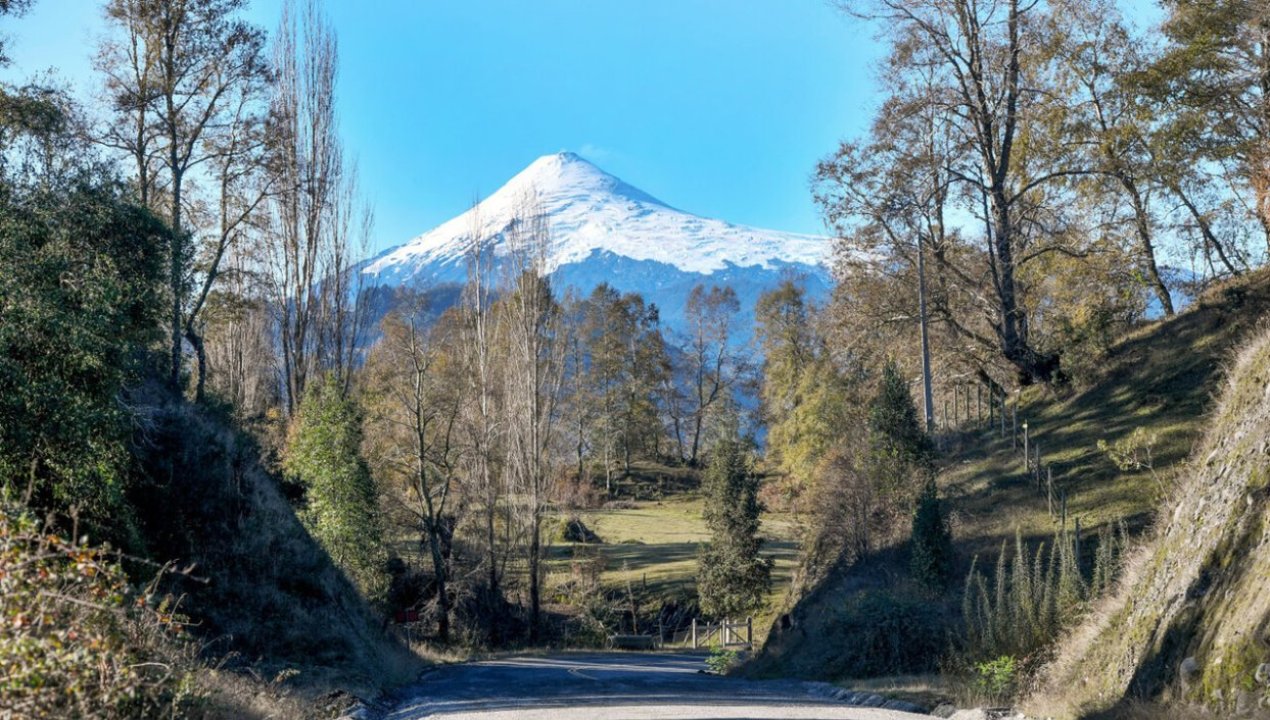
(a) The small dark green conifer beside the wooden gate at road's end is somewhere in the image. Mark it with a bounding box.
[697,428,772,617]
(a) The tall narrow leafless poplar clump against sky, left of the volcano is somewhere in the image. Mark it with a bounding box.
[268,0,371,413]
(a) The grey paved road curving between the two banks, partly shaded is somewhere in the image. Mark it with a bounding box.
[389,653,927,720]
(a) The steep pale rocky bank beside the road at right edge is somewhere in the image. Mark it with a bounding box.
[1033,333,1270,717]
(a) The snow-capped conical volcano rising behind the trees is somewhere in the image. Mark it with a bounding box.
[362,152,829,337]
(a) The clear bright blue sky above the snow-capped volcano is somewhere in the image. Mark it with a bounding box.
[0,0,878,249]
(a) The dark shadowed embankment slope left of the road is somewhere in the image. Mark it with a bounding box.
[132,392,423,717]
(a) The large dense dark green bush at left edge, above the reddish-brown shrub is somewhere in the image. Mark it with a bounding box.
[0,176,168,550]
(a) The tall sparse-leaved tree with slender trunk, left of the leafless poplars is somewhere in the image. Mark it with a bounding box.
[97,0,268,387]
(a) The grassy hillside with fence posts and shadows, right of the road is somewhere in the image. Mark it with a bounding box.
[751,272,1270,679]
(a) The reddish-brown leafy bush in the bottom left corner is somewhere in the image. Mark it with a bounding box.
[0,508,202,719]
